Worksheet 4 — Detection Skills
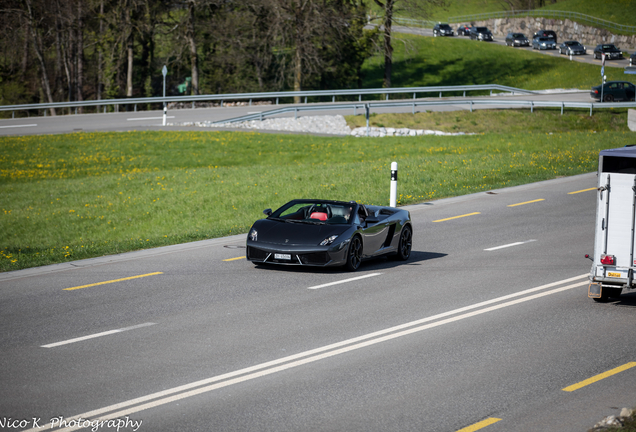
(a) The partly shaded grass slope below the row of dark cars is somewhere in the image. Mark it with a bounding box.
[363,33,626,90]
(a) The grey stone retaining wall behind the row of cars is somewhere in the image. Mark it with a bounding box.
[462,17,636,53]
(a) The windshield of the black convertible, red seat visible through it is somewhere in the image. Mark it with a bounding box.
[268,200,357,224]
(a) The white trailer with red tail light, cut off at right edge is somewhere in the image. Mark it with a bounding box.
[588,147,636,301]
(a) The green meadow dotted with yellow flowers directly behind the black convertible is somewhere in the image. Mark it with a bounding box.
[0,111,633,271]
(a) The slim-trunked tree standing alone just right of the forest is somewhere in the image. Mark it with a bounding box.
[373,0,446,88]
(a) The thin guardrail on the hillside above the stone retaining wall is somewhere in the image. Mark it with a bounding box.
[448,9,636,34]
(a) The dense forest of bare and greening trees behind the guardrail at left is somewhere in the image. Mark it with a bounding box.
[0,0,382,114]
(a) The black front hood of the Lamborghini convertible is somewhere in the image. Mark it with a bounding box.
[253,219,351,246]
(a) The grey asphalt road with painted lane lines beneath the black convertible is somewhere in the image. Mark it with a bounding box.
[0,174,636,432]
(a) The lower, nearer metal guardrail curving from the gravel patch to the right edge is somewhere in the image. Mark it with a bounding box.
[211,99,636,126]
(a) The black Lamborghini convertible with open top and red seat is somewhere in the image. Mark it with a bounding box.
[247,199,413,271]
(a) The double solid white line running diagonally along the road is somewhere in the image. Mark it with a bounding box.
[29,273,589,432]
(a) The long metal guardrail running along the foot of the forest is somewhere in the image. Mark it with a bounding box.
[0,84,536,115]
